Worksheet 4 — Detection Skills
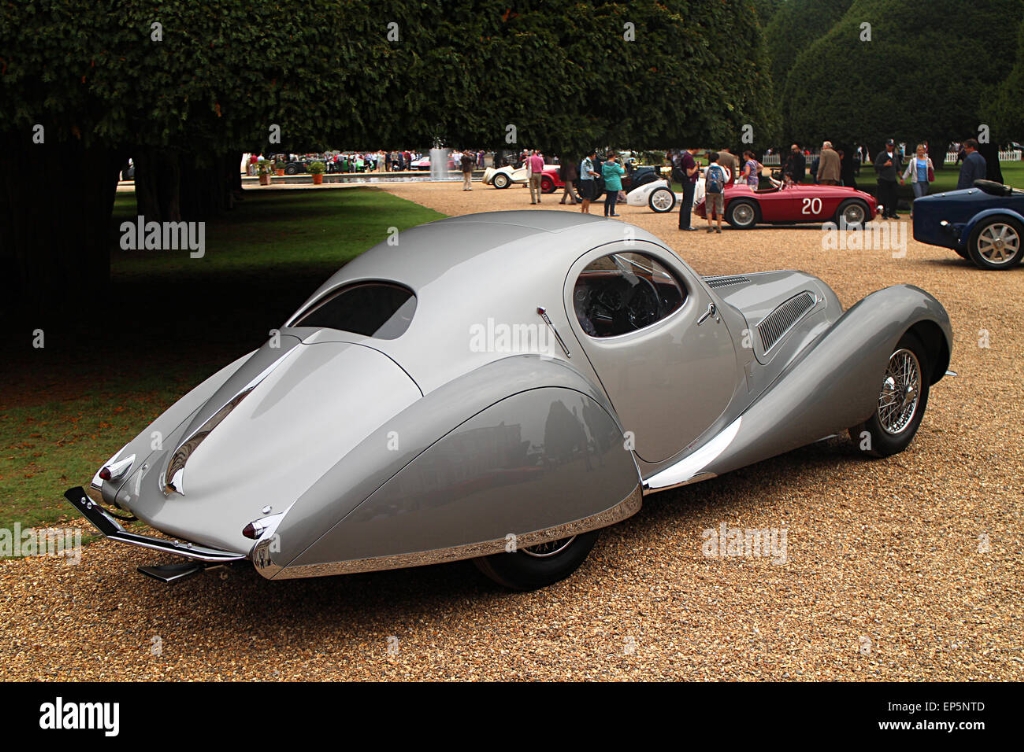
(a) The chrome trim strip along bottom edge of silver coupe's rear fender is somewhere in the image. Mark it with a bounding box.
[252,486,643,580]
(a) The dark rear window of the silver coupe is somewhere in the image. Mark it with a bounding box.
[292,282,416,339]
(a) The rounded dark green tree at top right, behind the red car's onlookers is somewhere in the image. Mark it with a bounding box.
[783,0,1024,151]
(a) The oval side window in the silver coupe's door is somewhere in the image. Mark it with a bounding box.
[572,253,686,337]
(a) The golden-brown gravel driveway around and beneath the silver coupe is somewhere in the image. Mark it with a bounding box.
[0,182,1024,681]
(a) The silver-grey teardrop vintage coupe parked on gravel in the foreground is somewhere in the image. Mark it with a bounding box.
[66,211,952,589]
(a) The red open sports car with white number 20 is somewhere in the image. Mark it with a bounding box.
[693,181,879,229]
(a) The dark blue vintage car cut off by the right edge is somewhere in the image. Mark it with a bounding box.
[913,180,1024,269]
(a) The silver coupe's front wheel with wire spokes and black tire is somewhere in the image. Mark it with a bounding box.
[850,332,930,457]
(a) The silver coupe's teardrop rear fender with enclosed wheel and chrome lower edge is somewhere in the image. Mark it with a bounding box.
[253,356,640,579]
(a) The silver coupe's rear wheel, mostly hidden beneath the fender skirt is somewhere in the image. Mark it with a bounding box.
[473,530,601,590]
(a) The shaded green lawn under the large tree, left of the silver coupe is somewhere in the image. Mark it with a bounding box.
[0,187,442,540]
